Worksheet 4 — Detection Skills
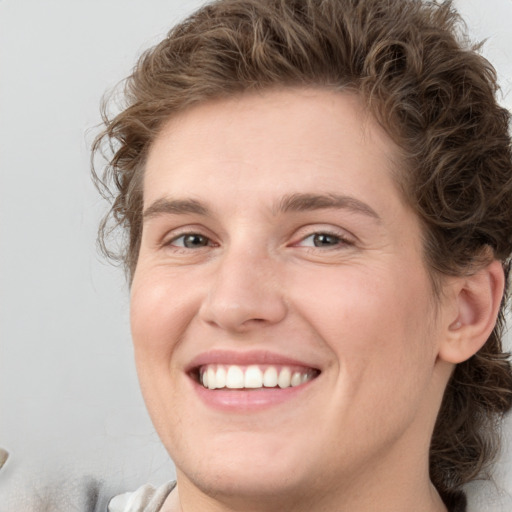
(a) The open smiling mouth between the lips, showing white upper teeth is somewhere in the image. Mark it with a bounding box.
[192,364,320,390]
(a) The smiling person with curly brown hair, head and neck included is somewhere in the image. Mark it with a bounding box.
[93,0,512,512]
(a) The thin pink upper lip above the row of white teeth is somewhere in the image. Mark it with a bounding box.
[186,349,319,372]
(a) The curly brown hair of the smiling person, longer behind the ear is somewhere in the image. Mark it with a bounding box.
[93,0,512,494]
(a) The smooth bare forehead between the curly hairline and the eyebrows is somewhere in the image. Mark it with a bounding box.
[144,89,404,210]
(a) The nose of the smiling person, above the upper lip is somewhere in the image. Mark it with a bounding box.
[200,249,287,332]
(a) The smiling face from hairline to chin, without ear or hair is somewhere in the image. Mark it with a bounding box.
[131,90,452,508]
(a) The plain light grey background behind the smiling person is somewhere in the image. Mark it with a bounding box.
[0,0,512,512]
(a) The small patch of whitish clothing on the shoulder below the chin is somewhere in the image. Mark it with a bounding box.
[108,482,176,512]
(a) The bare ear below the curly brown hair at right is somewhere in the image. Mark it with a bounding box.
[439,260,505,364]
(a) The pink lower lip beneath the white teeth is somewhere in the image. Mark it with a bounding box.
[192,377,318,412]
